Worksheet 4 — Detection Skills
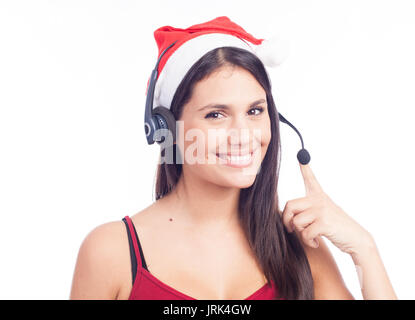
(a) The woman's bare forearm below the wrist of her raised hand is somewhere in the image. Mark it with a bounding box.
[351,235,398,300]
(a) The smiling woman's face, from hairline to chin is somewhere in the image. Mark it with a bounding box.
[177,66,271,188]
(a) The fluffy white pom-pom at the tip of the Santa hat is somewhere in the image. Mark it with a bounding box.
[255,35,289,67]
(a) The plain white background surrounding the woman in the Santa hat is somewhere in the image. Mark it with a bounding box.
[0,0,415,299]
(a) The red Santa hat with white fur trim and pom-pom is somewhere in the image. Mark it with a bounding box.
[146,16,287,109]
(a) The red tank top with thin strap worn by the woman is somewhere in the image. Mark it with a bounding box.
[122,216,278,300]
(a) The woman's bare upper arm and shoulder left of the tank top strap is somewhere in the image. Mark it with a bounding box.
[70,222,122,300]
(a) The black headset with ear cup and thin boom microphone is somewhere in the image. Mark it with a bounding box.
[144,41,310,165]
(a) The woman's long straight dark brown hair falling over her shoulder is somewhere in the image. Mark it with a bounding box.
[155,47,314,300]
